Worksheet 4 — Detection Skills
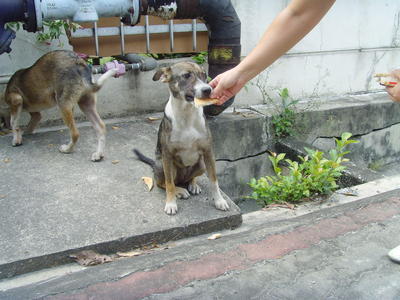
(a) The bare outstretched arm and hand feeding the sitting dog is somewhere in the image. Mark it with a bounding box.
[210,0,335,104]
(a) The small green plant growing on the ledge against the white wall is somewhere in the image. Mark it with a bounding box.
[272,88,299,137]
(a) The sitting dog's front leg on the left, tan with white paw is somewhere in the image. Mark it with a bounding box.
[162,155,178,215]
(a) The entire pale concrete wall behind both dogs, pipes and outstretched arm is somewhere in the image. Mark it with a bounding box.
[0,0,400,122]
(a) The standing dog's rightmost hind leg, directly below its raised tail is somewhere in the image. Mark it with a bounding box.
[78,94,106,161]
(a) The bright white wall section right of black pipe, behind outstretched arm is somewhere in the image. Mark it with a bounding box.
[232,0,400,105]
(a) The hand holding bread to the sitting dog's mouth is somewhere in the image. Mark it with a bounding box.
[210,68,247,105]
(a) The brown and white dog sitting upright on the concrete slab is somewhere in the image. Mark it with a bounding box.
[133,62,229,215]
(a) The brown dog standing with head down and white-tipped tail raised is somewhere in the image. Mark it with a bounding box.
[4,50,116,161]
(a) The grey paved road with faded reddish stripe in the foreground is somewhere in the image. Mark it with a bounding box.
[0,190,400,300]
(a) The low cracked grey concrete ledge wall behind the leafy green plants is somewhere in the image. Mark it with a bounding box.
[220,93,400,202]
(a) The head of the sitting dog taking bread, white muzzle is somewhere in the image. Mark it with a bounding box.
[153,62,212,102]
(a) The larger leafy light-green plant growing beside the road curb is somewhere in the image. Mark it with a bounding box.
[249,132,358,205]
